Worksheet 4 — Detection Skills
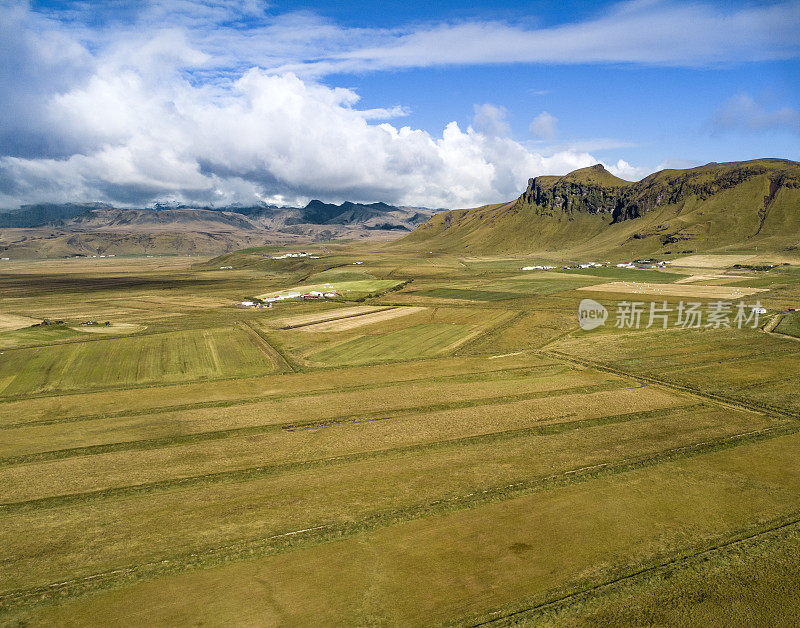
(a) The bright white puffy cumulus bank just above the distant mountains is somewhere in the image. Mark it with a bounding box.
[0,57,612,206]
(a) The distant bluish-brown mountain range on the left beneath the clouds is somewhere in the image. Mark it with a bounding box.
[0,200,442,258]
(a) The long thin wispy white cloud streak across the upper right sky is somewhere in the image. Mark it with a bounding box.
[279,0,800,75]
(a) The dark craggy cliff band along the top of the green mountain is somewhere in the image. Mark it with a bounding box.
[517,164,800,223]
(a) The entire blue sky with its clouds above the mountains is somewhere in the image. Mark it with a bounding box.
[0,0,800,207]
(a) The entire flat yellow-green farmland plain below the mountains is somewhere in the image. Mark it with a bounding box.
[0,249,800,627]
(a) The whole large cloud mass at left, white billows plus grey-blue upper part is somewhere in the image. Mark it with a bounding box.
[0,2,644,207]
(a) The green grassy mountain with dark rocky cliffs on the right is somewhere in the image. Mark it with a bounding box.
[393,159,800,259]
